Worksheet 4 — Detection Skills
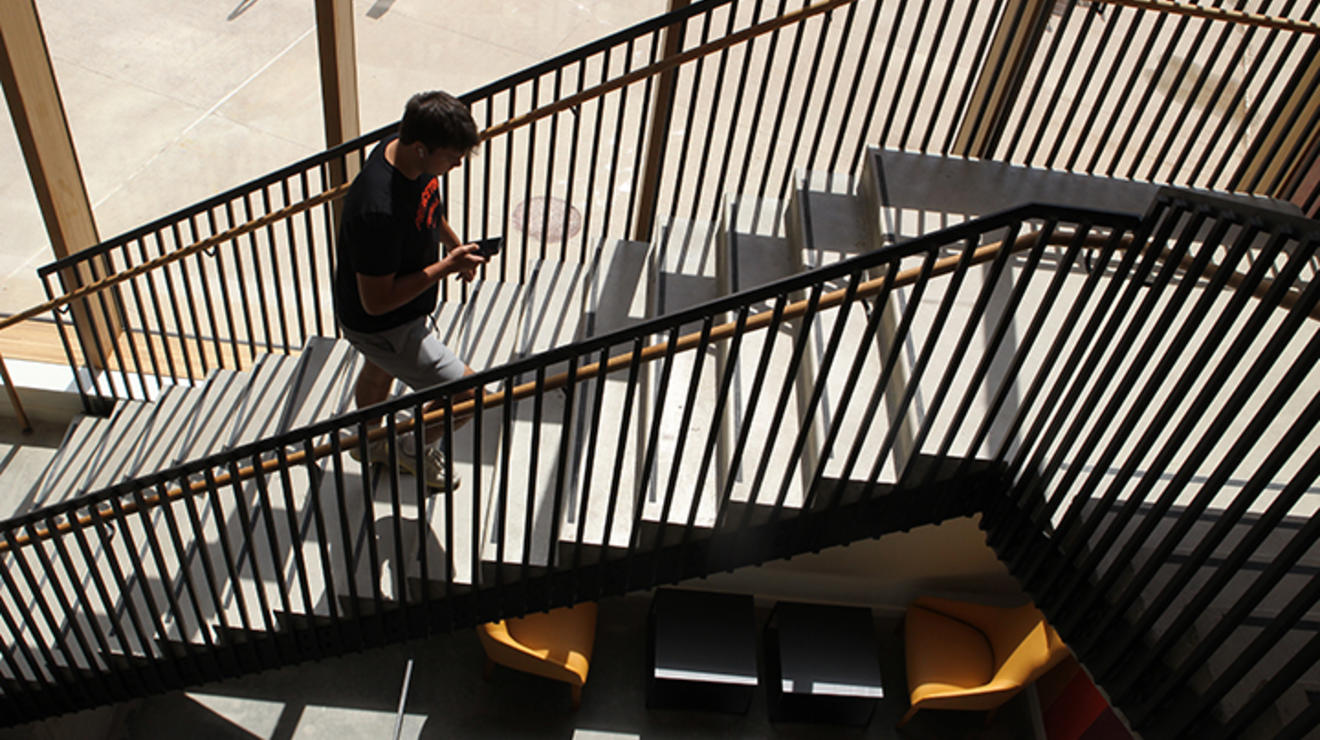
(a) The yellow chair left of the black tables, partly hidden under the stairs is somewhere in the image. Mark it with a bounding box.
[477,601,597,710]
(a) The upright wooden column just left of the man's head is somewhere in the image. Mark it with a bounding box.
[317,0,362,215]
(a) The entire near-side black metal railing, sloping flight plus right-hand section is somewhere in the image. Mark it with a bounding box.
[0,185,1320,737]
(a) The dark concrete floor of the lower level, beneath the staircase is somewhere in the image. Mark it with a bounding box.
[0,594,1031,740]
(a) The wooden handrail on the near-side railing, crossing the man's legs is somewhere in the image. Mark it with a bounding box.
[0,230,1108,553]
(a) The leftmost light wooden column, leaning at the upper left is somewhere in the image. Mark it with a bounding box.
[0,0,120,367]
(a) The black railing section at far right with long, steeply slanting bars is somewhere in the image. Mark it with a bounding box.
[989,193,1320,737]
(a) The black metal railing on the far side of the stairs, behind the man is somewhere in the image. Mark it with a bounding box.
[28,0,1316,408]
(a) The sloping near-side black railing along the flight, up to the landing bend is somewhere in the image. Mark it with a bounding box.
[0,201,1137,722]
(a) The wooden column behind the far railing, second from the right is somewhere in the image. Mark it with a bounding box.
[950,0,1053,157]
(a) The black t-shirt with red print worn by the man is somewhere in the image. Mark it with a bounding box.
[334,137,442,331]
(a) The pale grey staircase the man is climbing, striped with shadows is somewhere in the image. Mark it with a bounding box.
[0,144,1316,736]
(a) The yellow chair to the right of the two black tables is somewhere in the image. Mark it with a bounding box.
[898,596,1068,727]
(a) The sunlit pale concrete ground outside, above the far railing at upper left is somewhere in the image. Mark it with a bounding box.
[0,0,668,315]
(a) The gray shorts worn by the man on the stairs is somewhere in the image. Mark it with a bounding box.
[339,317,467,390]
